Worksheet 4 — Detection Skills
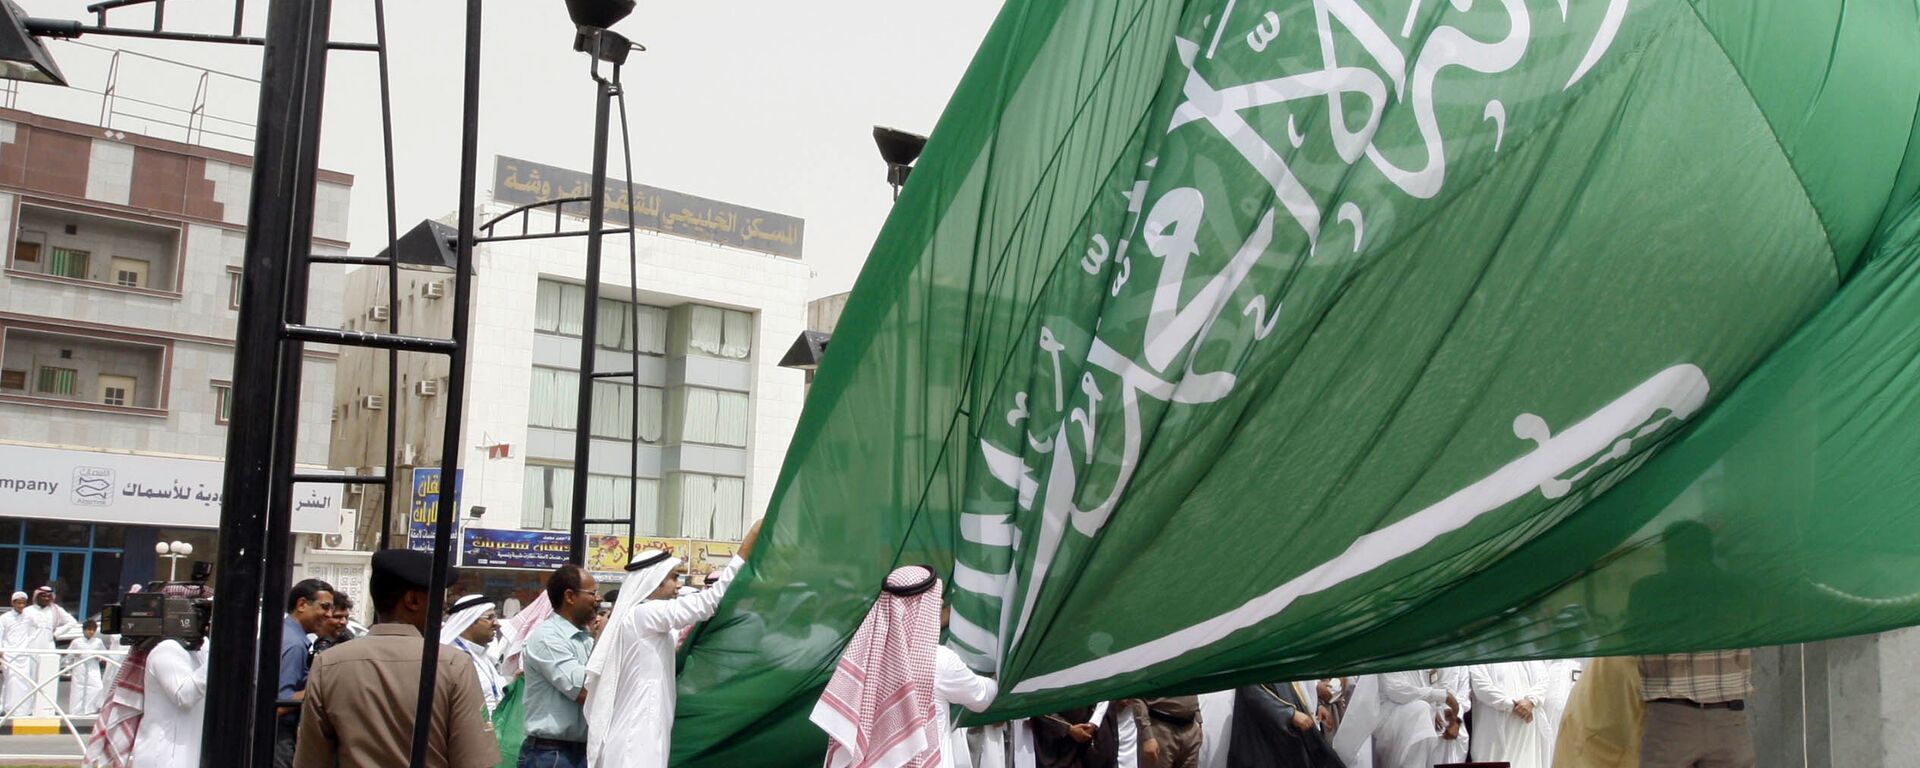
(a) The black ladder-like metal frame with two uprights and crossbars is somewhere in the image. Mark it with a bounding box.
[180,0,480,768]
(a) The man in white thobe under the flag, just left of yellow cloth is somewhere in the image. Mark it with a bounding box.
[1467,660,1553,768]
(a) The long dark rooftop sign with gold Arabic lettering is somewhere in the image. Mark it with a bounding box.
[493,156,806,259]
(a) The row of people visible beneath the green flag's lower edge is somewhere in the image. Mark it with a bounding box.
[890,652,1755,768]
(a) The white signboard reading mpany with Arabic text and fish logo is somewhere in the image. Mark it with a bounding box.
[0,444,342,534]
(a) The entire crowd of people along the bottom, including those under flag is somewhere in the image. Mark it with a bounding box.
[0,526,1755,768]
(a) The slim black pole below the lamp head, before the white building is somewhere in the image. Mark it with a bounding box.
[566,50,620,564]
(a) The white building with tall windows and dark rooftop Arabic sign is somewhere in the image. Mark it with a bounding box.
[334,157,810,599]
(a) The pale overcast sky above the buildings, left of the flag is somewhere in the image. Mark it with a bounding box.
[17,0,1000,298]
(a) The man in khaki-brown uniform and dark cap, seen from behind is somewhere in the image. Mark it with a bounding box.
[294,549,499,768]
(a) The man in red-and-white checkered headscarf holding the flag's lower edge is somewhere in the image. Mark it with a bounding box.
[812,564,998,768]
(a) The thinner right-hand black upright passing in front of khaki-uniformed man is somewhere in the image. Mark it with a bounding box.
[410,0,482,768]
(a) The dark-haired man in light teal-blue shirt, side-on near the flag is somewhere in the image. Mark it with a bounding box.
[518,563,599,768]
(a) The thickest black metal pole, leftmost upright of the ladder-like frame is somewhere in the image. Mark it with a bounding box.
[200,0,330,768]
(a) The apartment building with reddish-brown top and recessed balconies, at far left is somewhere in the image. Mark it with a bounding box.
[0,109,353,616]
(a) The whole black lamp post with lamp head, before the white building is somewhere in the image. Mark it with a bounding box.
[566,0,634,564]
